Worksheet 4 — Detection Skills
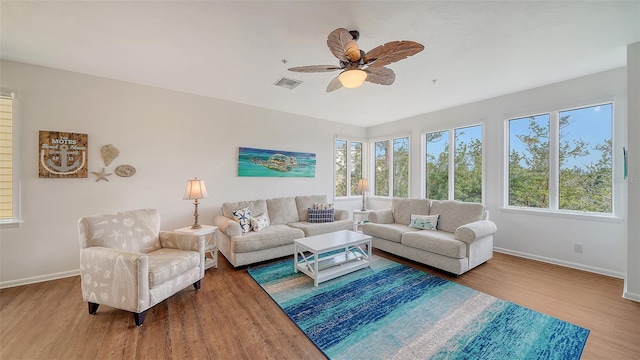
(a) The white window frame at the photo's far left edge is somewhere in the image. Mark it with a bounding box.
[0,88,23,228]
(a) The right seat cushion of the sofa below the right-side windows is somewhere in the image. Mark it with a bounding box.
[401,230,467,259]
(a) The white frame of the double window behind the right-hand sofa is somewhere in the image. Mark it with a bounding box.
[420,121,486,204]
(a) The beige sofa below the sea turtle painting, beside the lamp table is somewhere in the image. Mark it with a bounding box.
[214,195,353,267]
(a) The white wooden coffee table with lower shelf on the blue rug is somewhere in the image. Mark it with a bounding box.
[293,230,371,286]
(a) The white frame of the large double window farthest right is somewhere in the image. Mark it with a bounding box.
[500,98,622,222]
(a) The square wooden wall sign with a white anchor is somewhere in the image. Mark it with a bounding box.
[38,131,88,178]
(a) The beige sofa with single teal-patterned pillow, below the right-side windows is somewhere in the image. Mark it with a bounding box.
[362,199,497,275]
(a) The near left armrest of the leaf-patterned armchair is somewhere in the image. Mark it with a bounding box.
[80,246,150,313]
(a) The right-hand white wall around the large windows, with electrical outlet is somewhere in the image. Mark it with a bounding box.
[368,68,627,277]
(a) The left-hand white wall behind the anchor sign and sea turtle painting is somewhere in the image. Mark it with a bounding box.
[0,61,365,287]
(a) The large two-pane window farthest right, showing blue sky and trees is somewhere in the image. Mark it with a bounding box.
[508,103,613,213]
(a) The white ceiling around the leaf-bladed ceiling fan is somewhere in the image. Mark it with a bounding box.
[0,0,640,126]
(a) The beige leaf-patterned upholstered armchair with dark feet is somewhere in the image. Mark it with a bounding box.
[78,209,205,326]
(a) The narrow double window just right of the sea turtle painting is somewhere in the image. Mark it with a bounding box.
[335,139,363,197]
